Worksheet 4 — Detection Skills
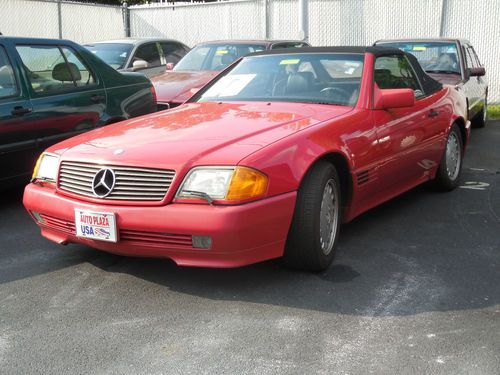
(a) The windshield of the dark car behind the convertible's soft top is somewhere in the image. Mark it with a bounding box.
[380,42,460,74]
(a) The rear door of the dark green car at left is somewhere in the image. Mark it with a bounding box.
[16,44,106,154]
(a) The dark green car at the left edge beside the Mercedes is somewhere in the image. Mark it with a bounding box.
[0,37,156,188]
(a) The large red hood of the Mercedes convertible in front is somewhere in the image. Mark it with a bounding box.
[49,102,352,171]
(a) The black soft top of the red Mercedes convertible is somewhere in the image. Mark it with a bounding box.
[247,46,443,95]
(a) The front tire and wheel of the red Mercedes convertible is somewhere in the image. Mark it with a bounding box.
[283,161,342,271]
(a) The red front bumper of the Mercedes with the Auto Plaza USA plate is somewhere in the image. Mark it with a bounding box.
[23,183,296,268]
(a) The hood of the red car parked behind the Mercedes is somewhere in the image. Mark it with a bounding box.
[151,71,219,103]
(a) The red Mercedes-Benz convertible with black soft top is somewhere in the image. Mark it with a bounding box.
[24,47,470,270]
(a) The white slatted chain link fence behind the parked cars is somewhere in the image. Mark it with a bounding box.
[0,0,500,103]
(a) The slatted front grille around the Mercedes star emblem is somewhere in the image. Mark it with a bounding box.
[58,161,175,201]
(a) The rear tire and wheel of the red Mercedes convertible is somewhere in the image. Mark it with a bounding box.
[435,124,464,191]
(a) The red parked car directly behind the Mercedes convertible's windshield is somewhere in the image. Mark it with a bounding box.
[151,40,309,110]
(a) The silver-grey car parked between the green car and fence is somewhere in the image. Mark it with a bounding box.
[84,38,189,77]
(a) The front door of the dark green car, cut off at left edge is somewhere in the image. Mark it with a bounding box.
[0,45,38,187]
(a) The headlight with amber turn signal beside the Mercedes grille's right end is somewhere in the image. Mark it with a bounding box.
[177,167,268,203]
